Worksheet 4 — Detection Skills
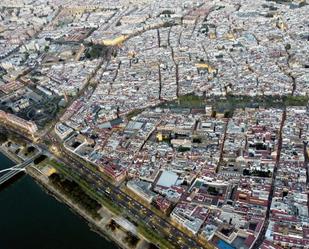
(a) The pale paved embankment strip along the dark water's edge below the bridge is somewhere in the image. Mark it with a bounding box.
[26,167,148,249]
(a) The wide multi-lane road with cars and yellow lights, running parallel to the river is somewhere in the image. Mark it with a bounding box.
[41,134,210,249]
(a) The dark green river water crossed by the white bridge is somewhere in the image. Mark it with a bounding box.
[0,154,117,249]
